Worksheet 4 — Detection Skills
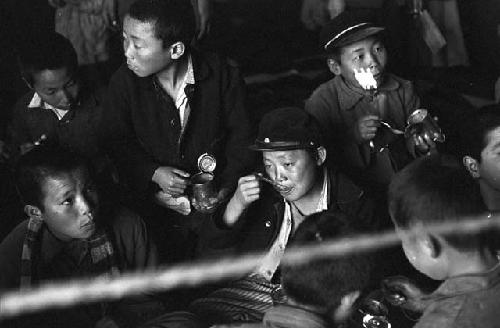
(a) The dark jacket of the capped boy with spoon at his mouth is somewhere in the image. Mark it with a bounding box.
[201,169,384,255]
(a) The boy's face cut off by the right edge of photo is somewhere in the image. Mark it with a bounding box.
[477,127,500,192]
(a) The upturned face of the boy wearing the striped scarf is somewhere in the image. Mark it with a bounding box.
[41,167,98,241]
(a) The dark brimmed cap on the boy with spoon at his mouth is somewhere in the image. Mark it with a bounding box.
[250,107,322,151]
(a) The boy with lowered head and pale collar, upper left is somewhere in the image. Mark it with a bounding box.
[7,33,103,165]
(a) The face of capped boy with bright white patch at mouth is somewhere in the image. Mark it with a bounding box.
[332,36,387,87]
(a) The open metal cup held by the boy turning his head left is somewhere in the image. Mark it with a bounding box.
[190,172,218,213]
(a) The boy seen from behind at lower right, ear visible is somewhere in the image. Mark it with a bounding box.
[389,155,500,328]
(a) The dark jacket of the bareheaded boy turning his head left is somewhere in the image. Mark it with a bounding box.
[103,51,253,194]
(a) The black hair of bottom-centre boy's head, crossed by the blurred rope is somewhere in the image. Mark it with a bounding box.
[281,211,375,313]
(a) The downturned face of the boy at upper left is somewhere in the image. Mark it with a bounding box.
[32,67,80,110]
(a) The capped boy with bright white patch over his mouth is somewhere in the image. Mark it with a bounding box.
[306,12,426,190]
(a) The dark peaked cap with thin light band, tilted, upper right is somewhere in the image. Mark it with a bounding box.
[319,11,385,51]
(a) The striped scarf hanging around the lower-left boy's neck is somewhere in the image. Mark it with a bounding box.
[20,218,119,289]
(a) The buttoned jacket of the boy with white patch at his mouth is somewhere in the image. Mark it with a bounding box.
[305,74,420,185]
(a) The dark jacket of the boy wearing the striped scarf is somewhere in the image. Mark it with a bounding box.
[0,208,165,328]
